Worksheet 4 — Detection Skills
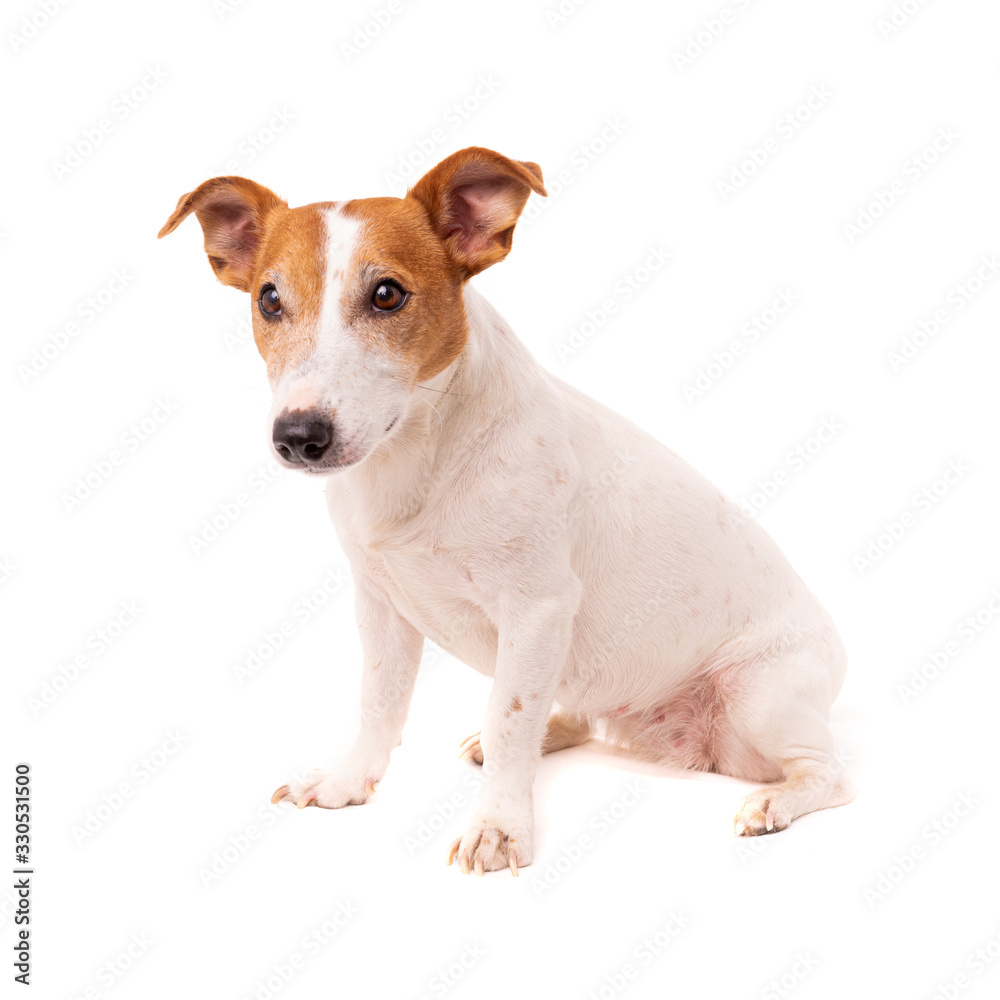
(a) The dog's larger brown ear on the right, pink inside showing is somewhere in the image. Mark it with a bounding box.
[407,146,545,278]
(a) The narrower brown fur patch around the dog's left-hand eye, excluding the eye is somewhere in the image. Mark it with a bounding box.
[250,203,332,381]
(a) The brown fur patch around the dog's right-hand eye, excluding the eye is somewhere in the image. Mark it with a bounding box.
[340,197,468,385]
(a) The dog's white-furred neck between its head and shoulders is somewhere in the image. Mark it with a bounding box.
[337,286,548,527]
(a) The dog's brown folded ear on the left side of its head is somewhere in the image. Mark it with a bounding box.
[157,177,288,292]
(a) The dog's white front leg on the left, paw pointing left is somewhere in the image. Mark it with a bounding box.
[271,574,424,809]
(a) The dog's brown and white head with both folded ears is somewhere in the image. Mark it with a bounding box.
[159,147,545,474]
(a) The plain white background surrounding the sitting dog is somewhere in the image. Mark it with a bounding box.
[0,0,1000,1000]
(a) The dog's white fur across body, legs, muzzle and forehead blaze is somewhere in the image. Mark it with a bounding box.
[274,213,851,870]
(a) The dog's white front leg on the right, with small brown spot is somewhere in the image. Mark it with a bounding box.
[448,578,579,875]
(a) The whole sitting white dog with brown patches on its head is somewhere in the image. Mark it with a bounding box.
[159,147,853,875]
